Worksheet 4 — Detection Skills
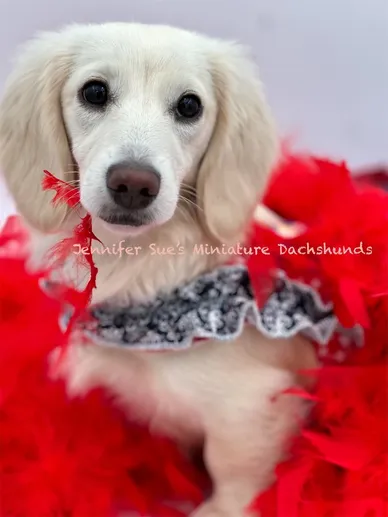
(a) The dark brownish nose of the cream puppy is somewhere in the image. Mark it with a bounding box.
[106,162,160,210]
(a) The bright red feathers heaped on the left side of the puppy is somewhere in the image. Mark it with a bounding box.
[0,225,206,517]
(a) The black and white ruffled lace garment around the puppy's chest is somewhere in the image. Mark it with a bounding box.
[81,265,360,356]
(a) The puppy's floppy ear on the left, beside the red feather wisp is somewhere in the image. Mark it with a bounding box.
[0,33,72,232]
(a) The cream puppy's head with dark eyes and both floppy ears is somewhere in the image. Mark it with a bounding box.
[0,24,277,241]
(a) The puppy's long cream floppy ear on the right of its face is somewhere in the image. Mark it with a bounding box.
[197,44,278,243]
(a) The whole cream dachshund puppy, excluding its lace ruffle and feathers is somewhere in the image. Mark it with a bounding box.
[0,23,315,517]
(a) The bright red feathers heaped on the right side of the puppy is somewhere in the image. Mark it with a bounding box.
[248,156,388,517]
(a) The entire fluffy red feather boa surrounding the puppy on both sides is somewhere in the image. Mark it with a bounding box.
[0,156,388,517]
